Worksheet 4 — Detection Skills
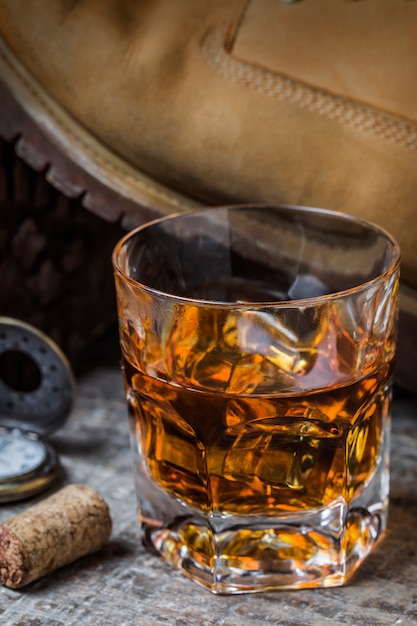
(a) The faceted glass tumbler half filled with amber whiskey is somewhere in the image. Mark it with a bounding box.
[113,205,400,594]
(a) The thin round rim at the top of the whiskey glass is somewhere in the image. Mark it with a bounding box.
[111,202,401,309]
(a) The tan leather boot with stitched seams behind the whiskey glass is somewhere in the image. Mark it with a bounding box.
[0,0,417,386]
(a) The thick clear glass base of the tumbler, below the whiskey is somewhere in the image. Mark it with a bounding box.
[136,422,389,594]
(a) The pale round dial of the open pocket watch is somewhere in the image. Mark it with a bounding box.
[0,434,47,480]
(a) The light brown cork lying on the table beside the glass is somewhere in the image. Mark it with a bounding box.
[0,485,112,589]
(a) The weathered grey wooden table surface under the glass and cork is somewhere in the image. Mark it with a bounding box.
[0,336,417,626]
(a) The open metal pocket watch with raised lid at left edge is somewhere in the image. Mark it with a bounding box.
[0,317,75,503]
